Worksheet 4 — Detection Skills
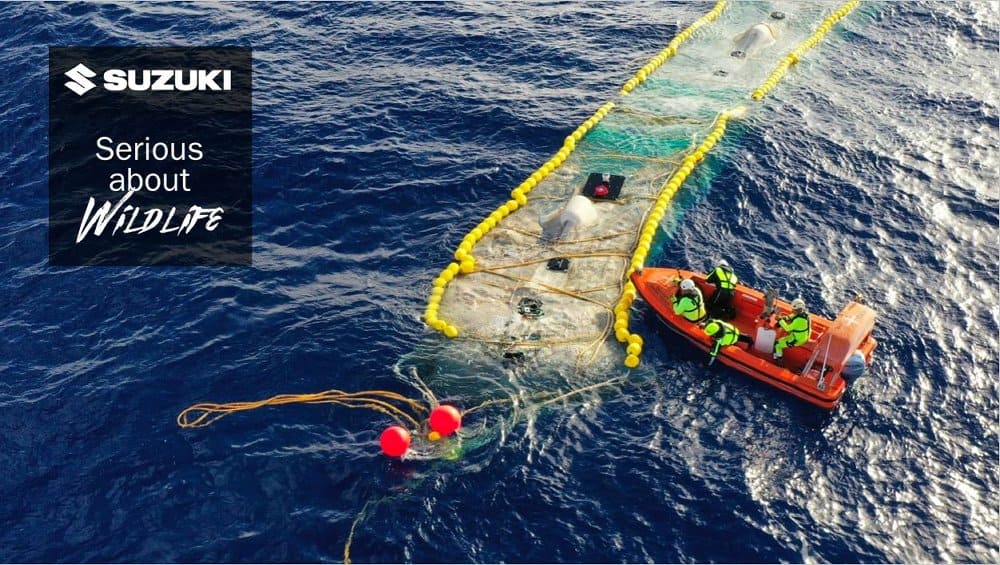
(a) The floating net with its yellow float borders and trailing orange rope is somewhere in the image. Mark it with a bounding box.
[178,0,857,452]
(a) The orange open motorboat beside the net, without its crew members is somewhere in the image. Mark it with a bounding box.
[632,267,876,410]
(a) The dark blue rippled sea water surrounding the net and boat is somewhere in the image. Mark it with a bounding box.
[0,2,1000,562]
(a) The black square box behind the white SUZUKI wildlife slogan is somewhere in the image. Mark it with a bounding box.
[48,47,253,266]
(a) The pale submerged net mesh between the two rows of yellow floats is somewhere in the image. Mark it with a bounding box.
[418,2,837,402]
